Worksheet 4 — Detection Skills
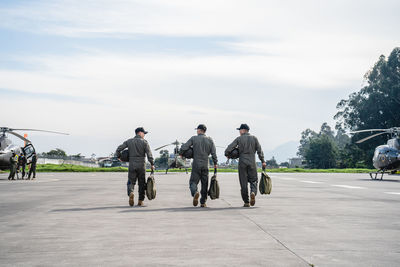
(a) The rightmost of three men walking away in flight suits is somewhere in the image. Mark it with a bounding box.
[225,124,266,207]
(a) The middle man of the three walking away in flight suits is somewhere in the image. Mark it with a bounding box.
[179,124,218,208]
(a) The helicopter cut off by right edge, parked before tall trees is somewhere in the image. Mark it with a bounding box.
[351,127,400,180]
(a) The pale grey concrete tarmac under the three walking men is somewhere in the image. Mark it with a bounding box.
[0,173,400,266]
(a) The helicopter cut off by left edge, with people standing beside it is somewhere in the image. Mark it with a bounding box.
[0,127,68,170]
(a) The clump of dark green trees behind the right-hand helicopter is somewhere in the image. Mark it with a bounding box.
[297,47,400,168]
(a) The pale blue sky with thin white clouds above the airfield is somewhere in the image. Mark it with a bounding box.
[0,0,400,160]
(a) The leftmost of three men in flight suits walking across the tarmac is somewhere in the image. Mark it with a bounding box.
[116,127,154,207]
